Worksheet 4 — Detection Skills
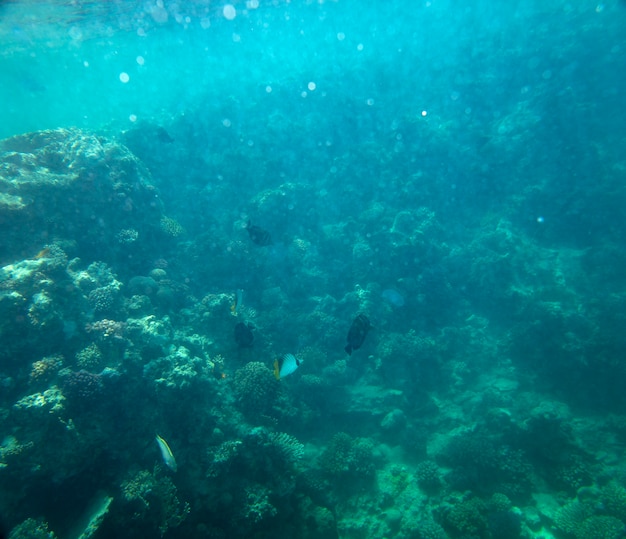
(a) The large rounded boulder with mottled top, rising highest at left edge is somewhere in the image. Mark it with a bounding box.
[0,129,161,266]
